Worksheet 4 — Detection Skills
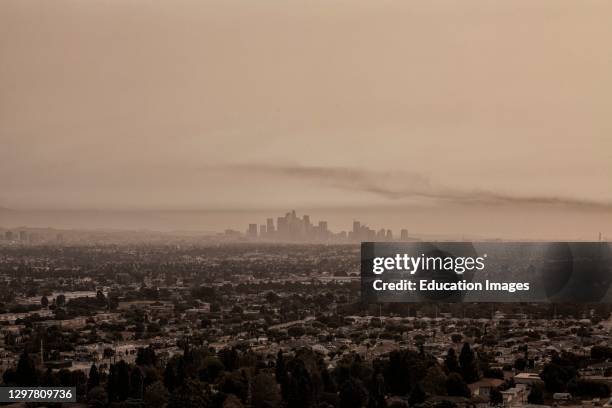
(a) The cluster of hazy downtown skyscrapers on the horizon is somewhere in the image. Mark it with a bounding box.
[234,210,409,242]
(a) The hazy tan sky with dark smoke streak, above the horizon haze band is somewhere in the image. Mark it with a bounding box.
[0,0,612,236]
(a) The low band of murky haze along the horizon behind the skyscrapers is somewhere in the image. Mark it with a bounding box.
[0,206,612,241]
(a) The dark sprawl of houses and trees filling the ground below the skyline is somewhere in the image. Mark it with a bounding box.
[0,239,612,408]
